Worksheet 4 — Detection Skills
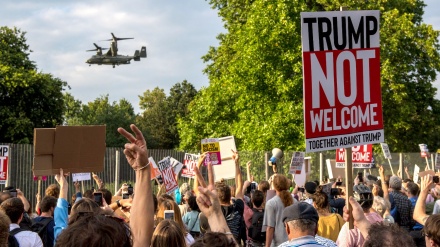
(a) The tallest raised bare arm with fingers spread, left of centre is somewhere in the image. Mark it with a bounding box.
[118,124,154,247]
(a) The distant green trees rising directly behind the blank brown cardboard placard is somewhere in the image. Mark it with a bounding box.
[64,93,136,147]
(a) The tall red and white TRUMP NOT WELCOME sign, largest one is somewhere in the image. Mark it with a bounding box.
[301,10,384,152]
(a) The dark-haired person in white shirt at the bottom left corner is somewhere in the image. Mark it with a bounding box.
[0,197,43,247]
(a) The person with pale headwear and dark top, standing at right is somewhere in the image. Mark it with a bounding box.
[389,176,414,232]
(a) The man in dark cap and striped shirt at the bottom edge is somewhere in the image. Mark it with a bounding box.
[277,202,324,247]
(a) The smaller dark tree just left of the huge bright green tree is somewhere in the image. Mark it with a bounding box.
[136,80,197,149]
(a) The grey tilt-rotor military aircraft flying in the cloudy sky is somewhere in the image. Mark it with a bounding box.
[86,33,147,68]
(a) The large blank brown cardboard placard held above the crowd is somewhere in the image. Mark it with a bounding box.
[33,125,106,176]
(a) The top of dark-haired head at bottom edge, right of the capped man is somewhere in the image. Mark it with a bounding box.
[363,222,416,247]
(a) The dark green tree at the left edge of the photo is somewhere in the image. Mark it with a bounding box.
[0,27,67,143]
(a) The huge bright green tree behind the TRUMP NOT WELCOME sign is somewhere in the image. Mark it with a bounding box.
[179,0,440,151]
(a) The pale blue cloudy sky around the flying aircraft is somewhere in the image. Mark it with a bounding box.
[0,0,440,111]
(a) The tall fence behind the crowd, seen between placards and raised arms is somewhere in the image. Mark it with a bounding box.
[0,144,434,210]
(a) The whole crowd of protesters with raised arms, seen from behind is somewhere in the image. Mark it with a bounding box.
[0,125,440,247]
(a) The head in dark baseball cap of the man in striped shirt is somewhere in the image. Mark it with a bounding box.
[282,202,319,240]
